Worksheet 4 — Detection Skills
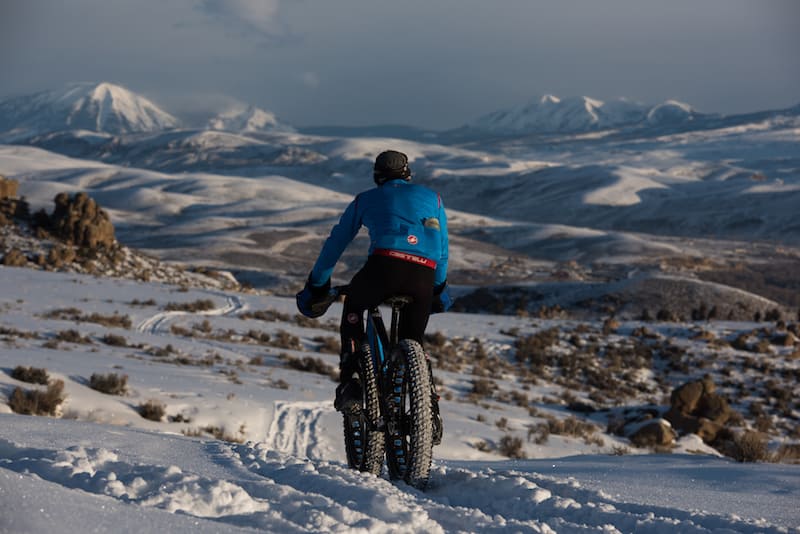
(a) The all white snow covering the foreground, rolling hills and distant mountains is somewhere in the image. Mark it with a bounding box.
[0,83,800,533]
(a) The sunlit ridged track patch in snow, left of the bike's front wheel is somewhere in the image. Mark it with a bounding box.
[264,401,333,459]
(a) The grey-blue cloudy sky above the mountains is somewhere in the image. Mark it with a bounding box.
[0,0,800,129]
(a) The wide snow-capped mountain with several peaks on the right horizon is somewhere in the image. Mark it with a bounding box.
[465,95,696,135]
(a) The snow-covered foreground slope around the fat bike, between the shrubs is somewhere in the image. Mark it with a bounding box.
[0,268,800,532]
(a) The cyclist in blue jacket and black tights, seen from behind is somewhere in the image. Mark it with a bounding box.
[297,150,451,413]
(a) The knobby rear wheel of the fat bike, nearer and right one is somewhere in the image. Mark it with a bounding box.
[385,339,433,489]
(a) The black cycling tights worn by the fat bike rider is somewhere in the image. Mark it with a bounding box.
[340,256,434,352]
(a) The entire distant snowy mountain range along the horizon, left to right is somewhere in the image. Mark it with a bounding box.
[0,83,800,142]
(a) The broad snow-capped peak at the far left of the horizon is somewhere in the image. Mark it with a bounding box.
[0,83,180,139]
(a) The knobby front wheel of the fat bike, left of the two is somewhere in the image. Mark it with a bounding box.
[343,343,384,475]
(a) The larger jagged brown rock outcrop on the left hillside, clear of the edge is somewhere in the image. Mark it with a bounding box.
[50,193,115,250]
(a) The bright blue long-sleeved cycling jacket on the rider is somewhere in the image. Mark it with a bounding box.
[311,180,448,286]
